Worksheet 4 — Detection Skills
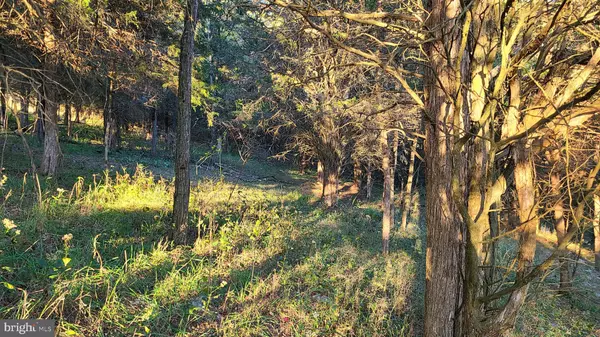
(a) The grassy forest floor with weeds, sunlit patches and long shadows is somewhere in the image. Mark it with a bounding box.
[0,120,600,337]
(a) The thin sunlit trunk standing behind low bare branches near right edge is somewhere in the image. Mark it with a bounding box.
[550,173,571,292]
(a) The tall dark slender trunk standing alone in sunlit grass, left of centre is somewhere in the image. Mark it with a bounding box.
[173,0,198,244]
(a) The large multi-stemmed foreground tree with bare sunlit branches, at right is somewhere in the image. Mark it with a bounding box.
[273,0,600,336]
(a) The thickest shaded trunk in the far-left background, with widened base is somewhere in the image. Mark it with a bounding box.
[41,78,60,176]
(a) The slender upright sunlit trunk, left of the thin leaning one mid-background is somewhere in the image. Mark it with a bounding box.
[379,131,394,255]
